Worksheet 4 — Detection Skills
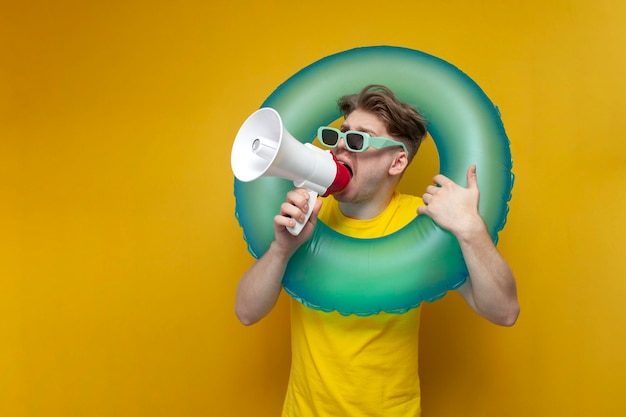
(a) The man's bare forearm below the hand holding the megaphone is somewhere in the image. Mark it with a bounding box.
[235,244,289,326]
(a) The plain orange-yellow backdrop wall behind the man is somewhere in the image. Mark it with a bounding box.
[0,0,626,417]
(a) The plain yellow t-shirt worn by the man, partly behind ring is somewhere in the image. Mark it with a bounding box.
[282,193,422,417]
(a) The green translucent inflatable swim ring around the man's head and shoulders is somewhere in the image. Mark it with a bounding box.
[235,46,514,316]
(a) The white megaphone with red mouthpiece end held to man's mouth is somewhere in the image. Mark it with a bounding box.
[230,107,351,236]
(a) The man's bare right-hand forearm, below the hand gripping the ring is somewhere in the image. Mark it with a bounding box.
[457,225,519,326]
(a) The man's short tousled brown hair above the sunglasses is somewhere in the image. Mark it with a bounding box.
[337,84,426,161]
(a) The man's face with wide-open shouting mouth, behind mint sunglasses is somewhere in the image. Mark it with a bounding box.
[332,109,401,203]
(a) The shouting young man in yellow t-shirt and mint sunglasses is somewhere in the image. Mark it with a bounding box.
[235,85,519,417]
